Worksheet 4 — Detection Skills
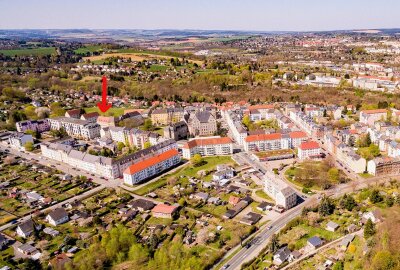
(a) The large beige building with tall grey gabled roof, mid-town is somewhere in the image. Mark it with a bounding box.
[187,111,217,136]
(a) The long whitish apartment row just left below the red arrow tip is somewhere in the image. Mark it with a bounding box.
[48,117,100,140]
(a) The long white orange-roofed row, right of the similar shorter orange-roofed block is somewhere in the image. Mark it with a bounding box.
[244,131,307,151]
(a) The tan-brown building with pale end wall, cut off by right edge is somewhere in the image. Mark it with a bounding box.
[367,157,400,176]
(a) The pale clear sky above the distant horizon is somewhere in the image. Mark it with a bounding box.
[0,0,400,31]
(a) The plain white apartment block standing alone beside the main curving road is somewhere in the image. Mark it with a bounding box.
[263,172,297,209]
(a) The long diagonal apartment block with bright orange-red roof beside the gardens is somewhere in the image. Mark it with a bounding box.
[123,149,181,185]
